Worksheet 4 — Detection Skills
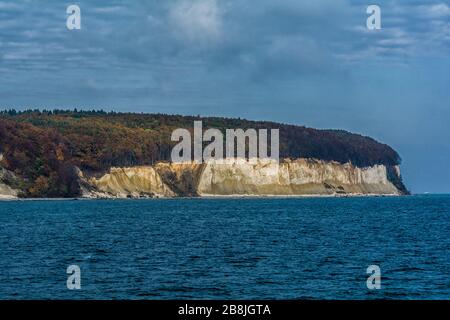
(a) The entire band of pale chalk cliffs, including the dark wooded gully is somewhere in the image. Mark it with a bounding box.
[80,159,406,198]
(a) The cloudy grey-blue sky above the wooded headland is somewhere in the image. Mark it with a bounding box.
[0,0,450,193]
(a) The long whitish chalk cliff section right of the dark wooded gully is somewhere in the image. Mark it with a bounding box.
[198,159,401,195]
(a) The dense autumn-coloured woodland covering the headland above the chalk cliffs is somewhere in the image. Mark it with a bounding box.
[0,109,401,197]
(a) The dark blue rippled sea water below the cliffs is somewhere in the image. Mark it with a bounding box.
[0,196,450,299]
